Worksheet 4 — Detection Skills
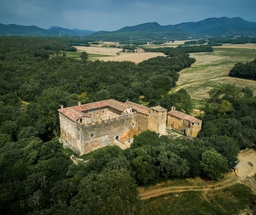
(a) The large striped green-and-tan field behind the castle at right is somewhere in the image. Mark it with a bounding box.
[175,44,256,100]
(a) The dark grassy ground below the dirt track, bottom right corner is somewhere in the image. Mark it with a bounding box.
[142,184,255,215]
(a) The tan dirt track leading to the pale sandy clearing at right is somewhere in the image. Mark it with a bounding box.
[139,149,256,200]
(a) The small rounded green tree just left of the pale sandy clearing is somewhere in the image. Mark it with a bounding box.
[201,149,228,180]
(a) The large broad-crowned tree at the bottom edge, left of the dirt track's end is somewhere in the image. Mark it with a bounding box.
[68,169,141,215]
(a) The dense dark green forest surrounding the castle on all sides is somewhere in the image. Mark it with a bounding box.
[0,37,256,214]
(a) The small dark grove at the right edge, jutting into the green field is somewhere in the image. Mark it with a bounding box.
[229,59,256,81]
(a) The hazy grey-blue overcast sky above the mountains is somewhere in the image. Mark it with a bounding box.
[0,0,256,31]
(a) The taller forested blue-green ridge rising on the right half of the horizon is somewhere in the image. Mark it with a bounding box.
[84,17,256,43]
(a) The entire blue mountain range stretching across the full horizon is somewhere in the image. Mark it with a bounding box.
[0,17,256,41]
